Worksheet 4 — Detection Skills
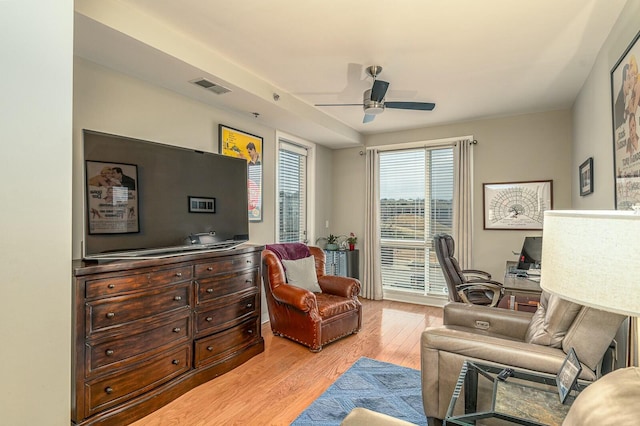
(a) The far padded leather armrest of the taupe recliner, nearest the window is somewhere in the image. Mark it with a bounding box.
[443,302,533,340]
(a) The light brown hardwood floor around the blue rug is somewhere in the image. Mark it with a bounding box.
[133,299,442,426]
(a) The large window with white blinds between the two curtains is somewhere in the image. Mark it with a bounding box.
[378,147,454,296]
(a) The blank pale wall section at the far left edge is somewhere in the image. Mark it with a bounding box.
[0,0,73,426]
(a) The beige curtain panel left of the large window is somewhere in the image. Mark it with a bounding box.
[360,149,383,300]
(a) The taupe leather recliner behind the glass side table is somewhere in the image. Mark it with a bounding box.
[421,292,625,424]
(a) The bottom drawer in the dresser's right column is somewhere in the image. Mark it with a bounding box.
[194,317,260,367]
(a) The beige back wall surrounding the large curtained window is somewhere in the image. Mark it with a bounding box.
[332,110,572,281]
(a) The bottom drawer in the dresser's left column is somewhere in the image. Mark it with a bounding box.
[85,345,191,416]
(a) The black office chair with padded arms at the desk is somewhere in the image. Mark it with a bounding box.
[433,234,504,306]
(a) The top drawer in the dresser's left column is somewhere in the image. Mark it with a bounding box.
[86,266,193,299]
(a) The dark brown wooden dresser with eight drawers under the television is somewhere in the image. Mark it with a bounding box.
[71,246,264,425]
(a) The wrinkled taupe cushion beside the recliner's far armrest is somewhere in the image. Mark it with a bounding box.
[525,292,582,348]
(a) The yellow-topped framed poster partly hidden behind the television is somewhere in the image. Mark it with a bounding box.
[219,124,262,222]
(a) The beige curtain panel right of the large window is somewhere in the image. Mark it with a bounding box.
[453,139,476,269]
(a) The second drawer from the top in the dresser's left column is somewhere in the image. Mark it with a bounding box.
[86,283,191,337]
